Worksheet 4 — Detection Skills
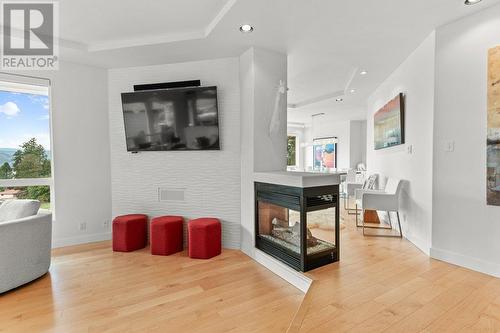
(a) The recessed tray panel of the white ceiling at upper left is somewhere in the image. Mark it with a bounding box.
[60,0,228,51]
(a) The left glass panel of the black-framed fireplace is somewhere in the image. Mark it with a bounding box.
[258,201,301,254]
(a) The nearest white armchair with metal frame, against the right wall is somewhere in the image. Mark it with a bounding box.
[356,178,403,238]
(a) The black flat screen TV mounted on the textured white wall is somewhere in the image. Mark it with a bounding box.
[122,87,220,152]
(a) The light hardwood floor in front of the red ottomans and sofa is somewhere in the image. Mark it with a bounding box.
[0,242,303,333]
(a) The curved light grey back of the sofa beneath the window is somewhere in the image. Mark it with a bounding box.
[0,212,52,293]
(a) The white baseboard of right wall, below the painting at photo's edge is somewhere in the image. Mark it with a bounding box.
[430,247,500,278]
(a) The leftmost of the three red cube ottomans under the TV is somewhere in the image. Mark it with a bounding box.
[113,214,148,252]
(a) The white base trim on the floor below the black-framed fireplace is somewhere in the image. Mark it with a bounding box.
[253,249,313,293]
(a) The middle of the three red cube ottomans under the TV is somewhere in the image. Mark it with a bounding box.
[150,216,184,256]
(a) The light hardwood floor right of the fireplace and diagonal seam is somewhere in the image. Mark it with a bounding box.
[288,206,500,333]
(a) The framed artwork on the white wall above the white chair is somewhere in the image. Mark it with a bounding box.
[373,93,405,150]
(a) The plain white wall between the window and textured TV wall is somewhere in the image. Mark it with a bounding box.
[14,62,111,247]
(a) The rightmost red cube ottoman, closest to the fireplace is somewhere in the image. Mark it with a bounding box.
[188,217,222,259]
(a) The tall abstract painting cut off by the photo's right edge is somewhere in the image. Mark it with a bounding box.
[486,46,500,206]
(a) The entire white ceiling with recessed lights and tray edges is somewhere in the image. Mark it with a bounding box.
[55,0,500,122]
